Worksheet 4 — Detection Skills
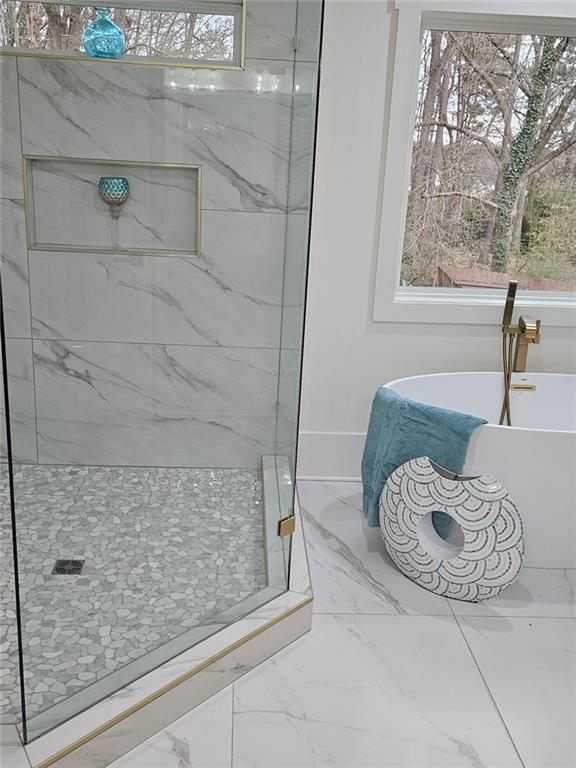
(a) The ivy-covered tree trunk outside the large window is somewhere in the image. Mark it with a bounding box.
[491,37,568,272]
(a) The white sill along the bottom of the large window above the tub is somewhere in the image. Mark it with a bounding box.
[372,288,576,327]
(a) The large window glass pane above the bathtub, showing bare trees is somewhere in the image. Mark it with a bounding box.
[401,30,576,291]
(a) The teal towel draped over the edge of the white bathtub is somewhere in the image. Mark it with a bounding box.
[362,387,487,538]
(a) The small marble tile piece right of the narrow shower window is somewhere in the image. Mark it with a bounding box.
[246,0,298,61]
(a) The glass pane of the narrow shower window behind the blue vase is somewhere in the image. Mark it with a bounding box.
[0,0,236,62]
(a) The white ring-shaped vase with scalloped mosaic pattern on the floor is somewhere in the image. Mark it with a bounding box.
[380,456,524,602]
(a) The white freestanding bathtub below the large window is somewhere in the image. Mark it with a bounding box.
[386,373,576,568]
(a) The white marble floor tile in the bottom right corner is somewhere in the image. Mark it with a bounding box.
[459,617,576,768]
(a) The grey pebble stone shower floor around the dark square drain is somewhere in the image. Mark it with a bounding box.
[0,464,266,723]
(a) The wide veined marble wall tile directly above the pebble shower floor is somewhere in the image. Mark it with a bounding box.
[34,341,277,468]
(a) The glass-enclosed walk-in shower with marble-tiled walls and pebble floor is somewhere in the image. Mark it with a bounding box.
[0,0,322,742]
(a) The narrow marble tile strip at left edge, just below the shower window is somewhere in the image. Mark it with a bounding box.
[0,56,24,199]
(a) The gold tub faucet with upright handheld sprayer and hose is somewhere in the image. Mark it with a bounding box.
[500,280,540,426]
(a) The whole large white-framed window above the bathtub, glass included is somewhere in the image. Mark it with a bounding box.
[374,2,576,324]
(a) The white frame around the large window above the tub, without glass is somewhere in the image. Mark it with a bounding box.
[373,0,576,326]
